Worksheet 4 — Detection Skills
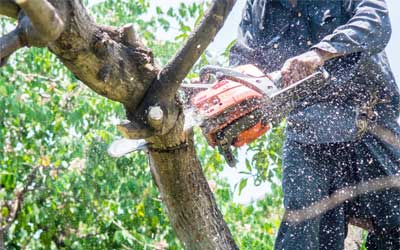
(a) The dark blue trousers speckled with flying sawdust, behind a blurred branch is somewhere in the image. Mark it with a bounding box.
[275,135,400,250]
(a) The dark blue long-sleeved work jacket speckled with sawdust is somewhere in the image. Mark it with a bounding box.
[230,0,399,143]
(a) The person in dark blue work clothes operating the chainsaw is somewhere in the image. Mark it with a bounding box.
[230,0,400,250]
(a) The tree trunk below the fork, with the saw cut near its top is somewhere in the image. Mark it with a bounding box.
[149,119,238,250]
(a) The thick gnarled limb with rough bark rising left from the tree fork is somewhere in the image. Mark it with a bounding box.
[49,0,159,110]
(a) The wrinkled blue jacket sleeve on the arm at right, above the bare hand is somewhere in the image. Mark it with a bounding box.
[313,0,392,55]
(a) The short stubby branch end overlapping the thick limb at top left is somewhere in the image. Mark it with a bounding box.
[16,0,64,42]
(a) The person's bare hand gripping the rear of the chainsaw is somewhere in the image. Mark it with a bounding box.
[281,50,335,87]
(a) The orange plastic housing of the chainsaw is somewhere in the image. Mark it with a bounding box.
[192,66,270,147]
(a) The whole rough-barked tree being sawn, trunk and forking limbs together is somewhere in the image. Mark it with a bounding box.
[0,0,237,249]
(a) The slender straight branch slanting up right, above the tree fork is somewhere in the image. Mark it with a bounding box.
[157,0,236,100]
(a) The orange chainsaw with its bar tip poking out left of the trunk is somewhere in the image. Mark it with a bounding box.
[109,65,329,167]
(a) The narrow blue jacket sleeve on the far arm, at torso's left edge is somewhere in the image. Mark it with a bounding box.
[229,0,254,66]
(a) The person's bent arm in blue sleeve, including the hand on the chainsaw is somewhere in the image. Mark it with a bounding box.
[282,0,392,84]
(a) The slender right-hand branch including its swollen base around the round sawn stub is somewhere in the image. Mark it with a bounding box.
[124,0,236,139]
